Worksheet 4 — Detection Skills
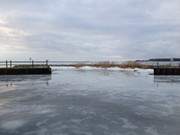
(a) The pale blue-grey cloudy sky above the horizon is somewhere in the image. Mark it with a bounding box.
[0,0,180,60]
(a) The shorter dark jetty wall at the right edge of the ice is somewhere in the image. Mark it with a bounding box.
[154,67,180,75]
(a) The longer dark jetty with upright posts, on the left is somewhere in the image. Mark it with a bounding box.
[0,60,52,75]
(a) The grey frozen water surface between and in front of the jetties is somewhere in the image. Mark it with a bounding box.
[0,68,180,135]
